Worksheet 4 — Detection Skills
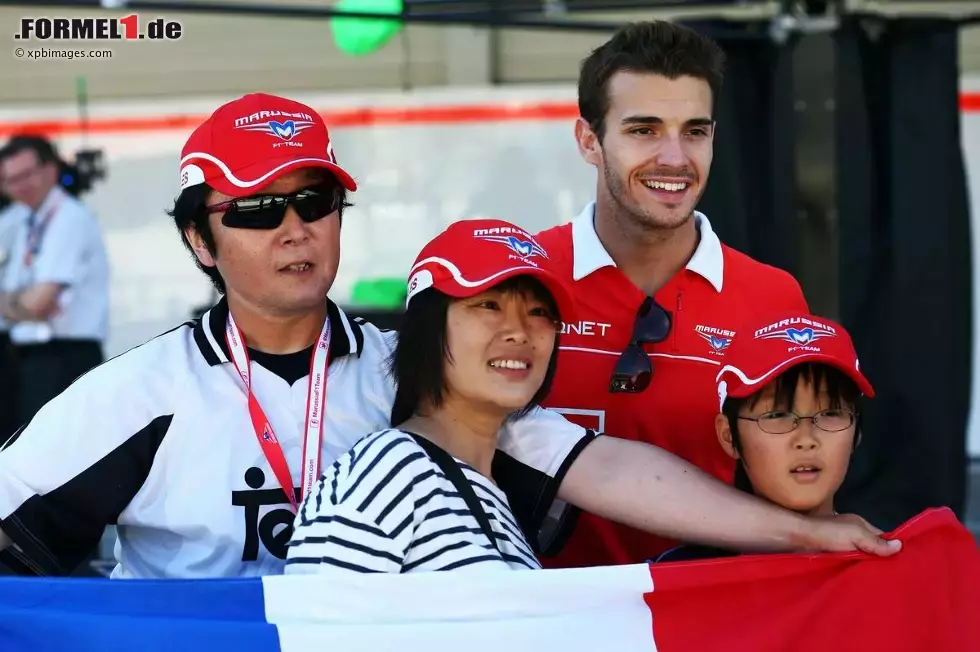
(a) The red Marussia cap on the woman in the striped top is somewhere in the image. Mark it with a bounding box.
[406,219,575,320]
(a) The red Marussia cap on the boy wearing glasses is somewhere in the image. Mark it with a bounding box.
[715,314,875,405]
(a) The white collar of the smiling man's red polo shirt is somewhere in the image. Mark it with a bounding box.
[572,202,725,292]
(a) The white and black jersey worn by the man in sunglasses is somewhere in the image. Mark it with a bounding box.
[0,299,592,578]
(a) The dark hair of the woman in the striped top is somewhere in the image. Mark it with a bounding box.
[389,276,561,427]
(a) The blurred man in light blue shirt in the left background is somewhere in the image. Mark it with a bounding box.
[0,136,109,426]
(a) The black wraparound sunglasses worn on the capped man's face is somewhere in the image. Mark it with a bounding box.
[207,185,344,229]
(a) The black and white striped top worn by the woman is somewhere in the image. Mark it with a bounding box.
[286,429,541,573]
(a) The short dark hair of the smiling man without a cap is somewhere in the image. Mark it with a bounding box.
[578,20,725,141]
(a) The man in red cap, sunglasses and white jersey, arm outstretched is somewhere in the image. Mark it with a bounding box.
[0,94,893,577]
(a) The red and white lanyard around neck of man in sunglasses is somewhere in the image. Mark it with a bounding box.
[225,313,330,511]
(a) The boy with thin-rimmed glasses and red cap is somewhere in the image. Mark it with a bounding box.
[657,314,874,561]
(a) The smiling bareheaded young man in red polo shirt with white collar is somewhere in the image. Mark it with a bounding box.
[538,22,808,567]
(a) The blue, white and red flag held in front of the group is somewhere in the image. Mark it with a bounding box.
[0,509,980,652]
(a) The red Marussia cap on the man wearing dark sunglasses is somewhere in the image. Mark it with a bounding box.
[180,93,357,197]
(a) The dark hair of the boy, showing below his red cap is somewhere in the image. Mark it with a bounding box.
[721,362,861,493]
